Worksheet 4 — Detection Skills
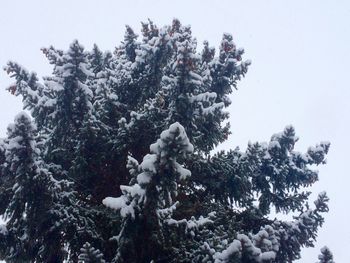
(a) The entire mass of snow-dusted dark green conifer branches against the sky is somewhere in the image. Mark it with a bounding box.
[0,19,333,263]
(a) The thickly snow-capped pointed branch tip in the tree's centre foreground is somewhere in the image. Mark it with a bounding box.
[102,122,193,218]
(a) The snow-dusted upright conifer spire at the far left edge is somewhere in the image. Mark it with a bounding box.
[2,113,64,262]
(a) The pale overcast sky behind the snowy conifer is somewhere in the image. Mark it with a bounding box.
[0,0,350,263]
